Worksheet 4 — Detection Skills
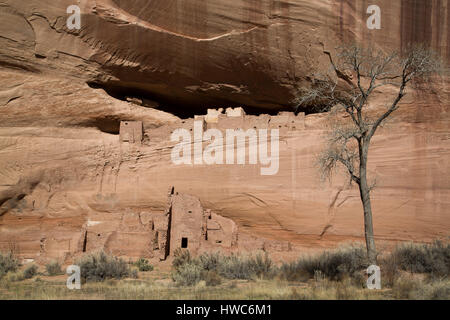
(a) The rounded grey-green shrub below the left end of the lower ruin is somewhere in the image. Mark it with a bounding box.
[75,251,130,282]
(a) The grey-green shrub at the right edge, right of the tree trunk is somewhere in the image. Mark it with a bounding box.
[391,241,450,277]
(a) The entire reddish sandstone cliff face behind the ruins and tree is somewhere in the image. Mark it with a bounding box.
[0,0,450,257]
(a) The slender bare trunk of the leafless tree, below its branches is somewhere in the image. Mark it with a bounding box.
[359,142,377,264]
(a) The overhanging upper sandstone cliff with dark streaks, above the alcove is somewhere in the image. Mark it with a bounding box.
[0,0,450,109]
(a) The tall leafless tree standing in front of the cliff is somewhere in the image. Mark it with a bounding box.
[297,45,440,263]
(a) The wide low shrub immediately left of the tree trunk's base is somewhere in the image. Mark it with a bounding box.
[279,247,369,282]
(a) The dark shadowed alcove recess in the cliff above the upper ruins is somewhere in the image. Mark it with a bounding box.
[88,82,298,119]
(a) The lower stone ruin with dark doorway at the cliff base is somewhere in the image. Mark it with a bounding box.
[78,187,237,260]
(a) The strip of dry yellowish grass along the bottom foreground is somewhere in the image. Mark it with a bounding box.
[0,278,390,300]
